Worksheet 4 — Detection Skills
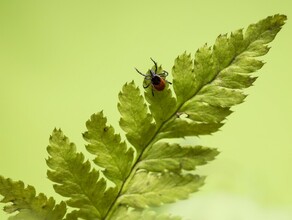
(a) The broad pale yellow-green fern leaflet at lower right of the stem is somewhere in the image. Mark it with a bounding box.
[118,170,205,208]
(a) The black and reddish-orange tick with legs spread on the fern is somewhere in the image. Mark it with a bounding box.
[135,58,172,96]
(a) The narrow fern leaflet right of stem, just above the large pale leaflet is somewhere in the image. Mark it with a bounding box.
[138,142,219,172]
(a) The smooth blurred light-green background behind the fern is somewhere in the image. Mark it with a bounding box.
[0,0,292,220]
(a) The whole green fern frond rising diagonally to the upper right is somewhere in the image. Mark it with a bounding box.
[0,14,286,220]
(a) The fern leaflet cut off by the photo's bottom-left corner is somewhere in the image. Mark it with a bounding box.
[0,176,66,220]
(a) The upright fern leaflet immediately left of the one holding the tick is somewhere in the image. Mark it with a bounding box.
[118,82,156,154]
